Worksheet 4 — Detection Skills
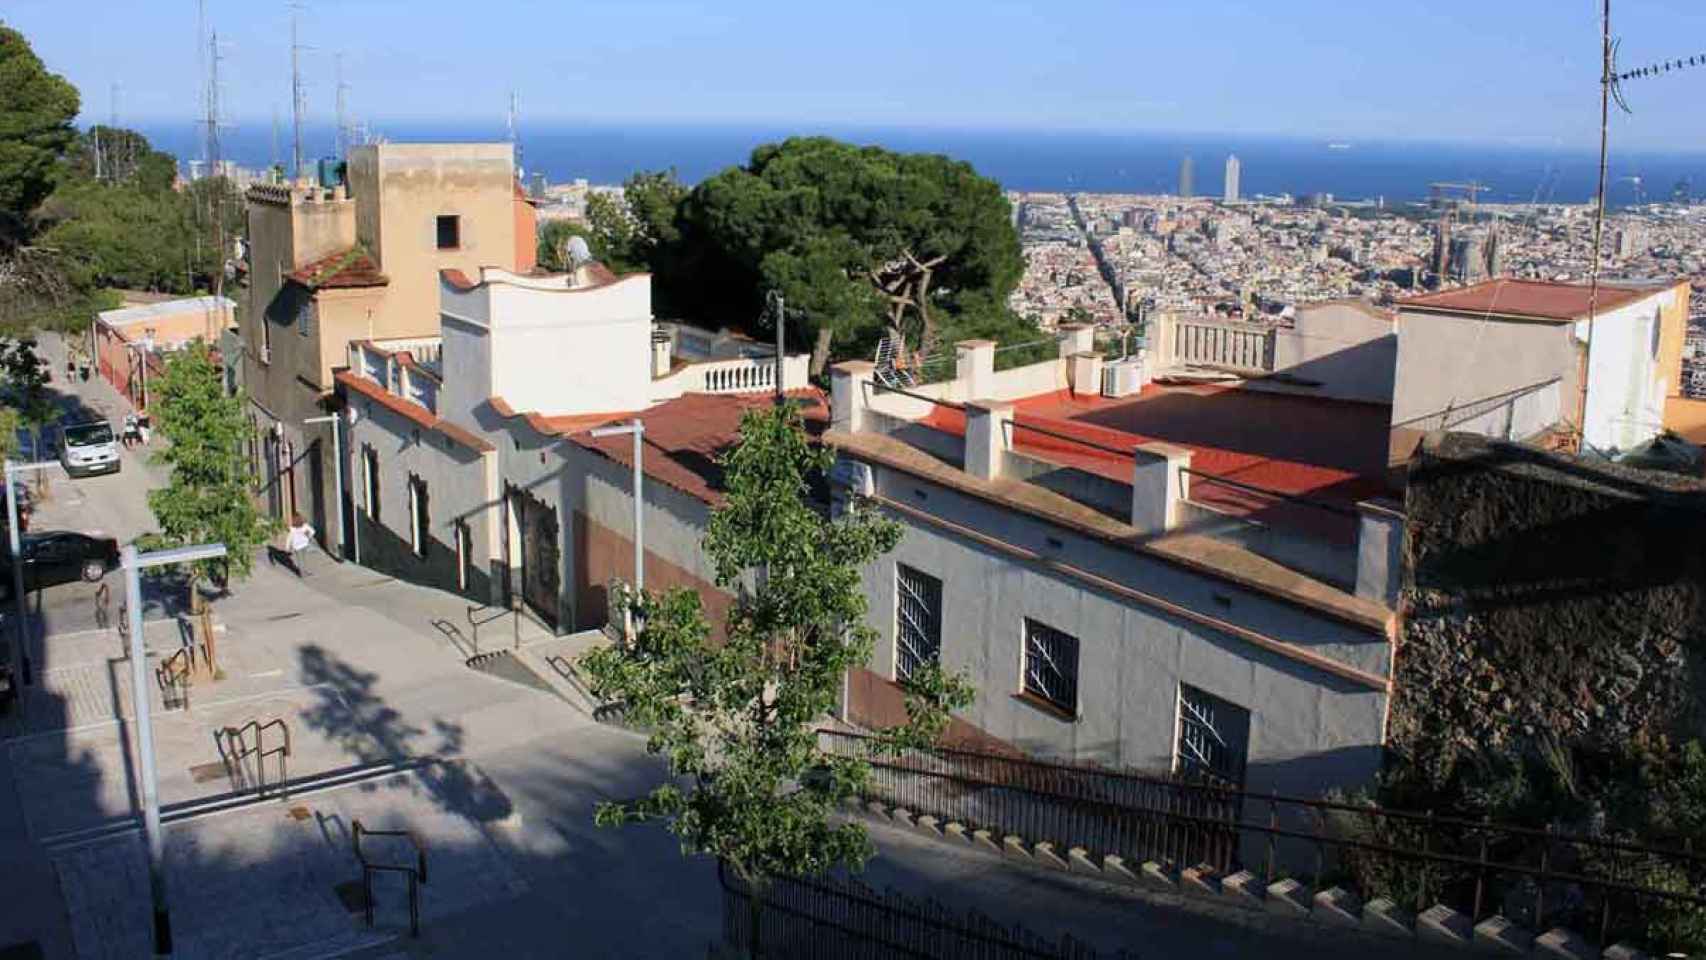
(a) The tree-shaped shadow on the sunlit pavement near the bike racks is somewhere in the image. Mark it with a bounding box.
[299,643,512,824]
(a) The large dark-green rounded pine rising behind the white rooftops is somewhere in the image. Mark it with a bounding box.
[682,136,1024,372]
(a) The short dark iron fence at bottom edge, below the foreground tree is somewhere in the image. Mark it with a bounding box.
[717,866,1133,960]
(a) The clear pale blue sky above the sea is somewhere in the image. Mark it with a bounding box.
[10,0,1706,152]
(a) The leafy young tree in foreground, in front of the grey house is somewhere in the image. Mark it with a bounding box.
[582,406,971,883]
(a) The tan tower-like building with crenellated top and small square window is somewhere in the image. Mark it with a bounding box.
[239,143,536,544]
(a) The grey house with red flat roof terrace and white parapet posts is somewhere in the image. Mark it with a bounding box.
[824,329,1402,793]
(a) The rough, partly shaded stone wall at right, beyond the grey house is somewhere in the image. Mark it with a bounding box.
[1389,433,1706,781]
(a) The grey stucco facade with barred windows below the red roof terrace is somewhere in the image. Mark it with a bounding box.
[863,467,1389,795]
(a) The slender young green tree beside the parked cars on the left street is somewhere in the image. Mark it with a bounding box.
[148,343,275,607]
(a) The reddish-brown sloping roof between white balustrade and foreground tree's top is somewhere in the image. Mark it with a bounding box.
[570,390,829,505]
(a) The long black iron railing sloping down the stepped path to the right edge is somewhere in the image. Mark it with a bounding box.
[819,730,1706,948]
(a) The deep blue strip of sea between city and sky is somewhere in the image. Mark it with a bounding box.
[138,119,1706,206]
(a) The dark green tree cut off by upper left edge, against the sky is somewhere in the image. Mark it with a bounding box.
[0,24,78,245]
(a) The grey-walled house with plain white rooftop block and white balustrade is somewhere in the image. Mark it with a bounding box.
[334,263,812,631]
